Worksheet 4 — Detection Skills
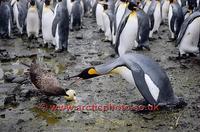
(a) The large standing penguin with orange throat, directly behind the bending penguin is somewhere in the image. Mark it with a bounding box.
[115,2,150,56]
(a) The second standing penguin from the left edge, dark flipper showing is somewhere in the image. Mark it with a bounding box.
[13,0,28,34]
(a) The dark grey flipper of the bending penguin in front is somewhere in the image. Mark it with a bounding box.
[127,61,157,104]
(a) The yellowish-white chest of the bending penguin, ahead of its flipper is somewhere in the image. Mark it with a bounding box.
[111,66,136,86]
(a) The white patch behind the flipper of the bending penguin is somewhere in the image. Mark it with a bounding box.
[145,74,160,101]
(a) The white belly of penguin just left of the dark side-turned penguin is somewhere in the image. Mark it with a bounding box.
[42,9,54,43]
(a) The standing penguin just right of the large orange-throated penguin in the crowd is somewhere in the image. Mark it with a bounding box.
[147,0,162,38]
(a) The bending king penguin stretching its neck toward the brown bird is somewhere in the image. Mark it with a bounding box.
[69,53,185,107]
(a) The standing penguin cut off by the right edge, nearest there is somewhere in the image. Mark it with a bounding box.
[176,11,200,56]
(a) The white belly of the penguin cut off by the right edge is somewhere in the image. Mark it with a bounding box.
[179,17,200,54]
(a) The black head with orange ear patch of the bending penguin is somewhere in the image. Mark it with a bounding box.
[67,67,99,79]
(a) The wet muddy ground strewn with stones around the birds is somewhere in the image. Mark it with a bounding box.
[0,15,200,132]
